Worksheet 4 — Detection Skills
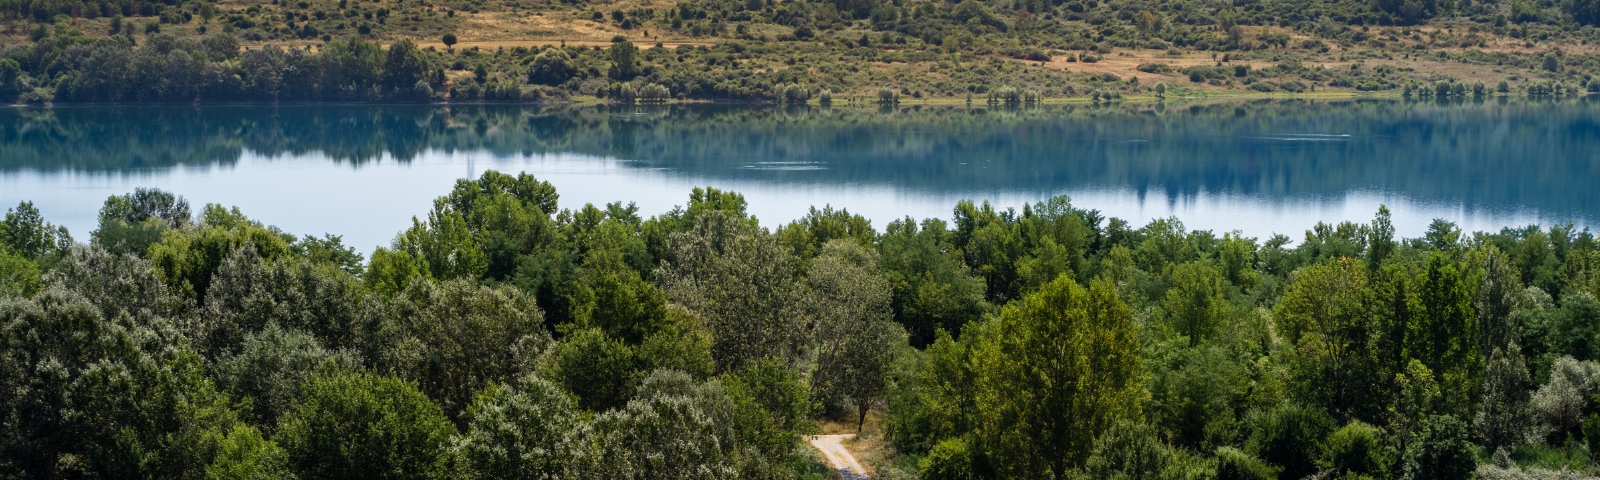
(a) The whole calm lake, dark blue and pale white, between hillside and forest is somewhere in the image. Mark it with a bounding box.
[0,96,1600,251]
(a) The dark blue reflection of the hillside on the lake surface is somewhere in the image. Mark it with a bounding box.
[0,98,1600,216]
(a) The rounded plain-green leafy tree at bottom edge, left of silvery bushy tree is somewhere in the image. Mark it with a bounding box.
[275,373,454,478]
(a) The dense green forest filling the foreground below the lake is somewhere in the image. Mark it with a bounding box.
[0,171,1600,480]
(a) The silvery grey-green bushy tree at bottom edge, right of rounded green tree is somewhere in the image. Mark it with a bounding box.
[456,376,592,478]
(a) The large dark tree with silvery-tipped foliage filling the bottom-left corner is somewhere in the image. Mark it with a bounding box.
[0,285,238,478]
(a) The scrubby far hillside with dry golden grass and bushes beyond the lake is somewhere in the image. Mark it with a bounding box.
[0,0,1600,104]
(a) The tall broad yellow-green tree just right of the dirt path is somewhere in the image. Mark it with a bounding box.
[978,277,1144,478]
